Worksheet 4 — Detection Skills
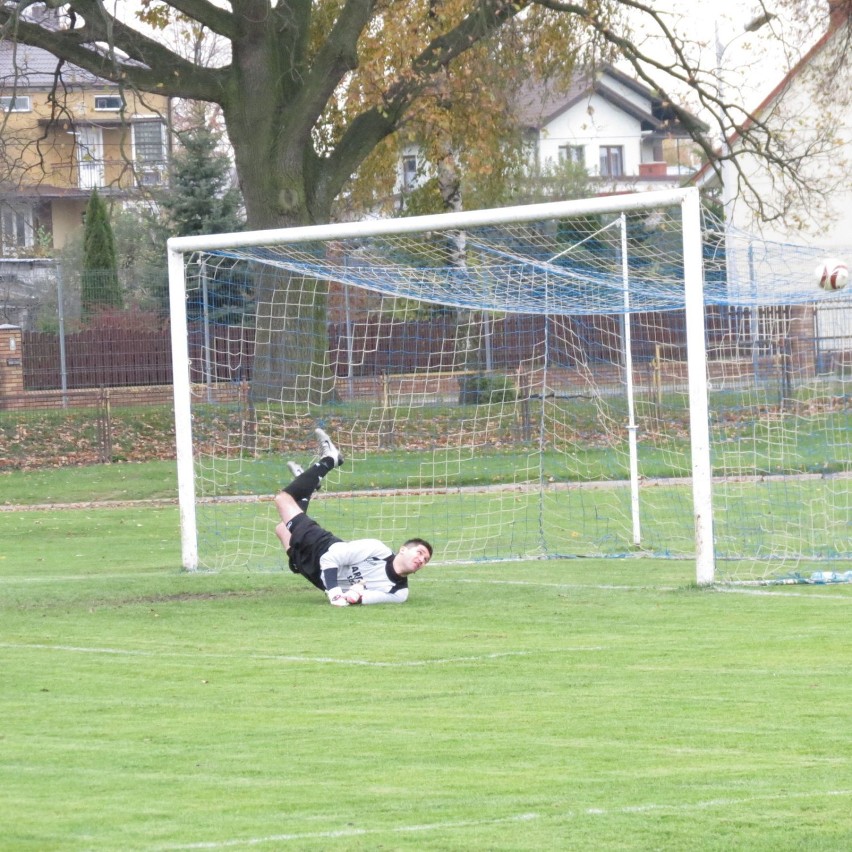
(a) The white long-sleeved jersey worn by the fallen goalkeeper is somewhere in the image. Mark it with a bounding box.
[320,538,408,604]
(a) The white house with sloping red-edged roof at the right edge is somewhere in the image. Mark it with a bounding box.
[695,0,852,353]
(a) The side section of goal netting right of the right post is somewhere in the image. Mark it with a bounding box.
[705,230,852,583]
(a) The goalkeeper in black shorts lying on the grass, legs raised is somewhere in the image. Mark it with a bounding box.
[275,429,432,606]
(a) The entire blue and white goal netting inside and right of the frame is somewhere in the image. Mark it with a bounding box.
[173,200,852,578]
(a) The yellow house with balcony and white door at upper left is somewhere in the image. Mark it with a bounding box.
[0,20,170,256]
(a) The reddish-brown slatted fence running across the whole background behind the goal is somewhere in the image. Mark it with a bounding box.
[6,306,852,391]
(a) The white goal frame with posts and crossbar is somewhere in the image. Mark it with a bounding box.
[168,188,715,585]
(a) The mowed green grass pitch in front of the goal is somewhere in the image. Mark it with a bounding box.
[0,466,852,852]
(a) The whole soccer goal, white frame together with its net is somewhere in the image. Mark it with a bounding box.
[169,189,849,584]
